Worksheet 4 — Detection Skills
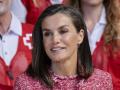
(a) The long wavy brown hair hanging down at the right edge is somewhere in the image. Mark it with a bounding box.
[103,0,120,44]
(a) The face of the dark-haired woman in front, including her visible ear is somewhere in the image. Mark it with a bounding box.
[42,13,83,62]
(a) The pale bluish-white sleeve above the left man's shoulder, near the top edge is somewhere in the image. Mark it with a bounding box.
[11,0,27,23]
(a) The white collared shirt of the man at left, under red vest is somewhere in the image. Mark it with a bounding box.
[0,13,22,65]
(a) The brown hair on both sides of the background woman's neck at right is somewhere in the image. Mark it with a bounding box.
[71,0,120,44]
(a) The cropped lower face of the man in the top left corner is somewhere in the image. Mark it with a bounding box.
[0,0,12,15]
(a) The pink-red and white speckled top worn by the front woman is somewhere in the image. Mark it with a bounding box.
[14,69,113,90]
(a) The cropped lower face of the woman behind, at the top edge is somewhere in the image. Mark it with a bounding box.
[81,0,103,6]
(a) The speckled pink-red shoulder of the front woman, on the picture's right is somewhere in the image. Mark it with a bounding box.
[79,69,113,90]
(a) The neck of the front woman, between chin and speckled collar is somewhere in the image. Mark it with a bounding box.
[52,54,77,76]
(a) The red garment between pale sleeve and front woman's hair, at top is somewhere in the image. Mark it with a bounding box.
[22,0,50,24]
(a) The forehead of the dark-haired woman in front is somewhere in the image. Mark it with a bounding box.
[42,13,73,28]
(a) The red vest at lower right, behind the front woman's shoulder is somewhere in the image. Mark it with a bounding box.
[92,39,120,90]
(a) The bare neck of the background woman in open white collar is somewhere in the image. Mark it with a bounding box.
[82,4,103,31]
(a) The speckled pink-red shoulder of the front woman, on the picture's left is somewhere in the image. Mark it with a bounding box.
[14,73,42,90]
